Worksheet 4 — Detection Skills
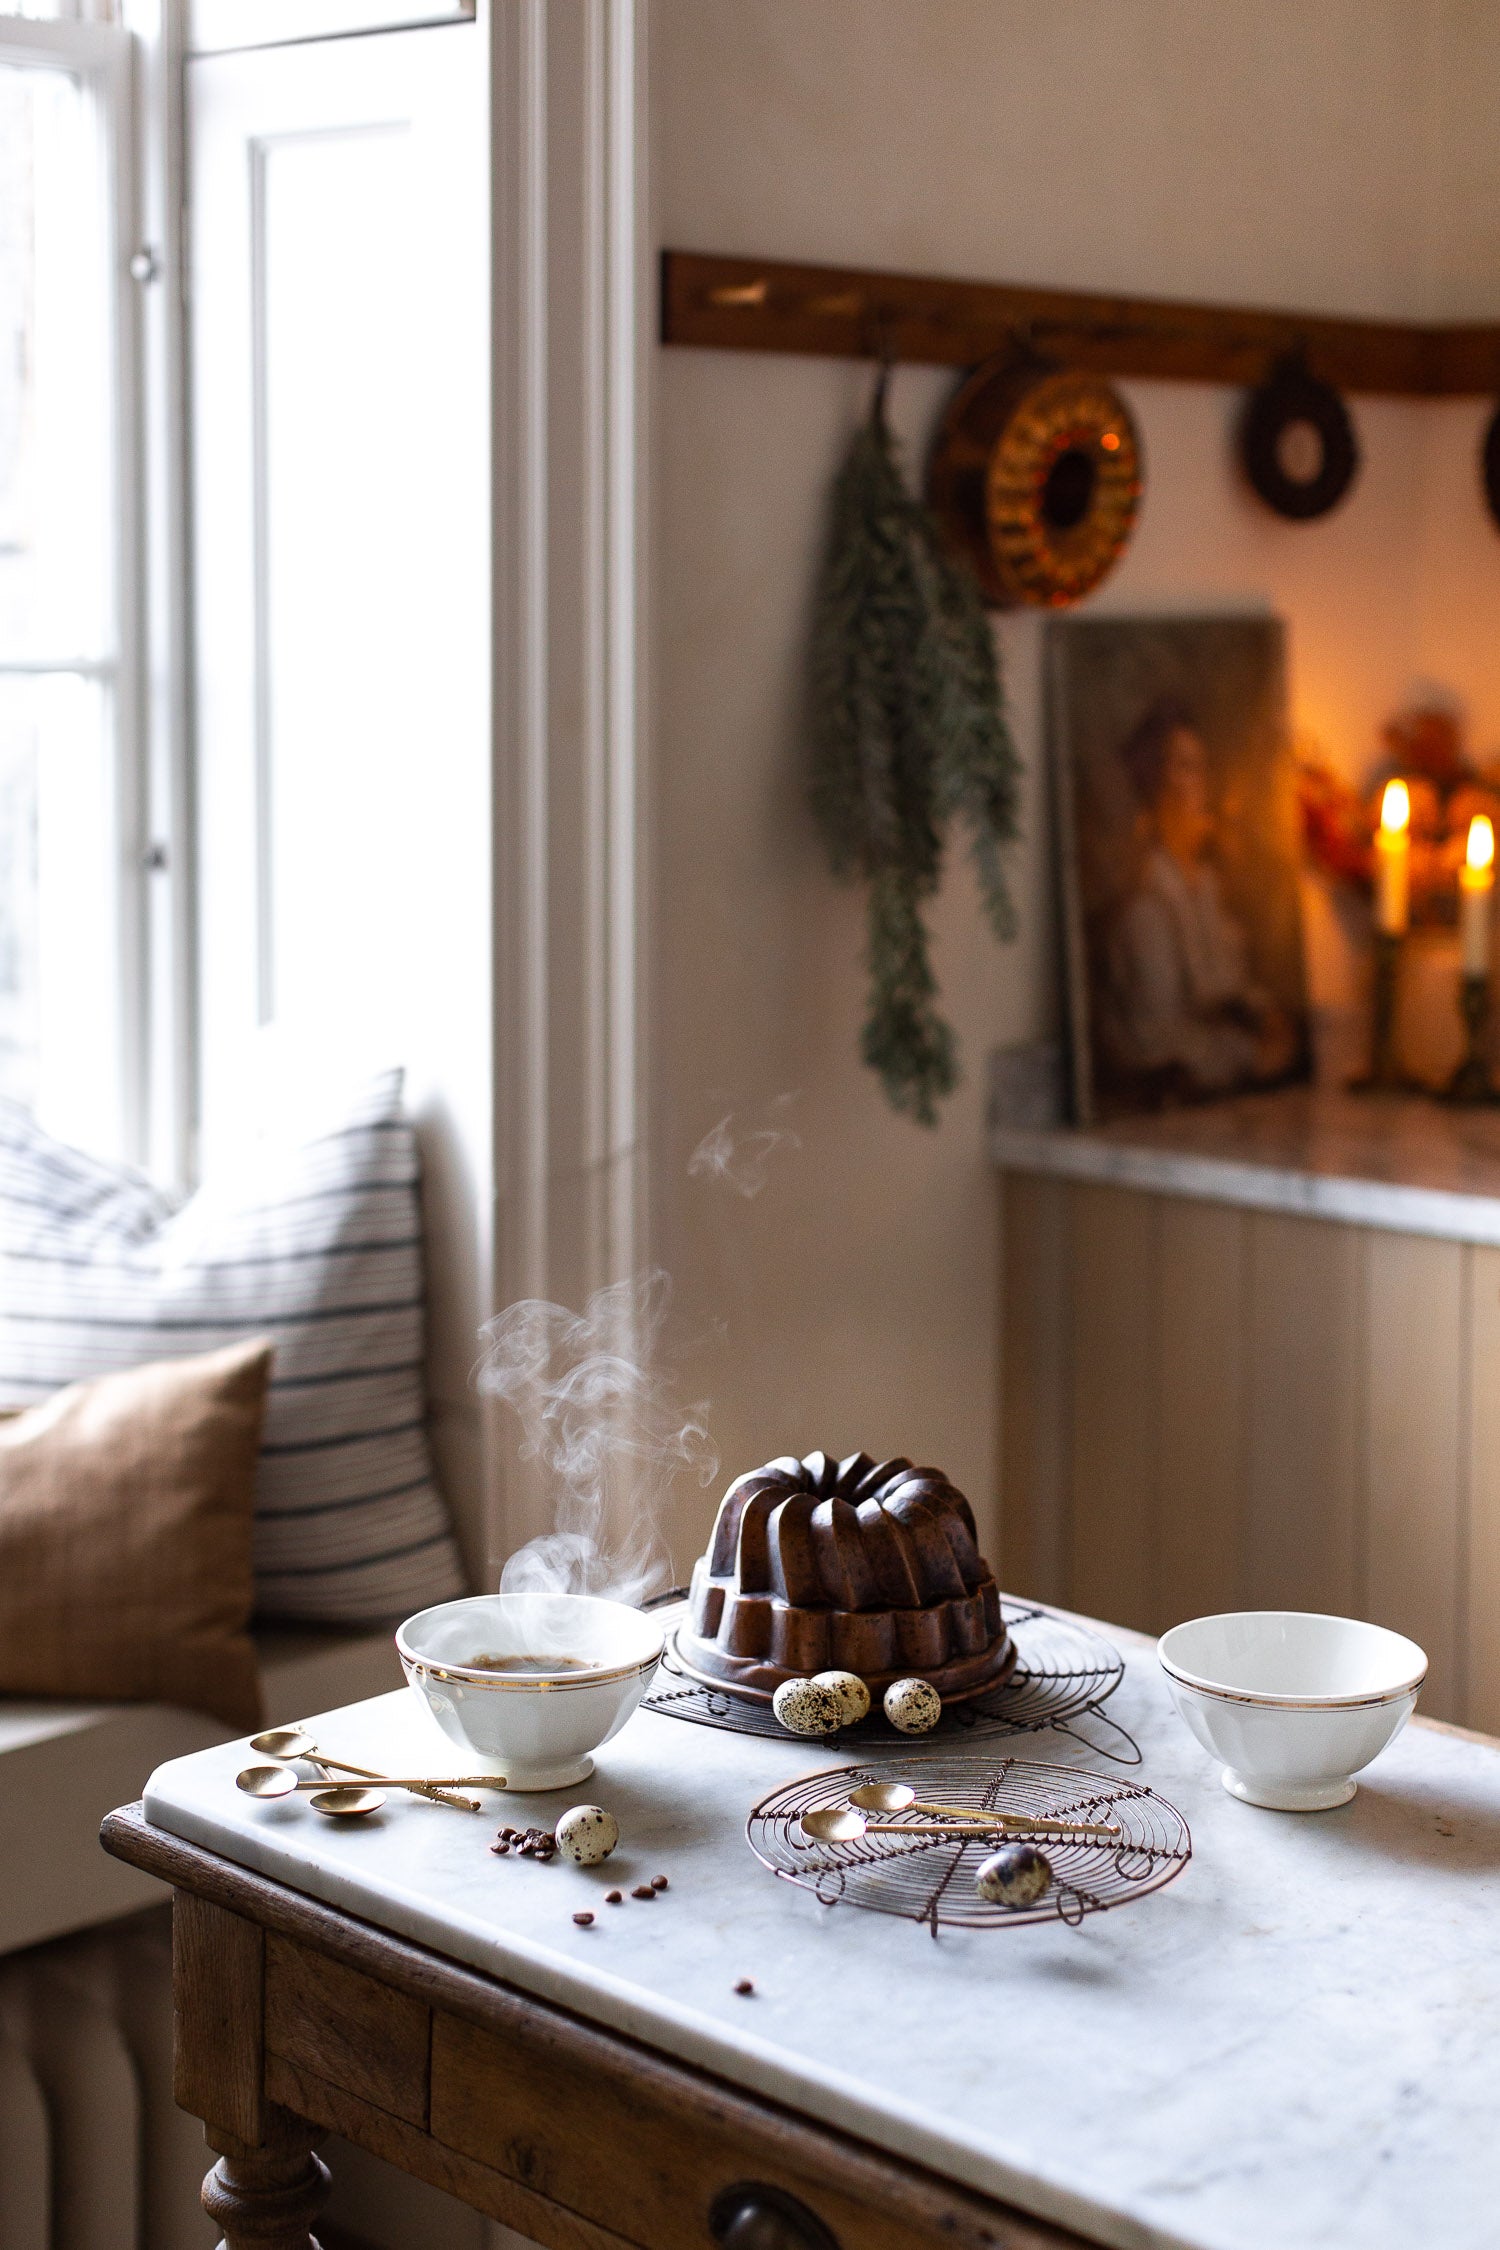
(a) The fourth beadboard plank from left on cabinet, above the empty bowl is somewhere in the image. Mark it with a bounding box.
[1241,1213,1365,1616]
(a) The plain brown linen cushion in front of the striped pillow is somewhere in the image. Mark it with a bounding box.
[0,1339,272,1728]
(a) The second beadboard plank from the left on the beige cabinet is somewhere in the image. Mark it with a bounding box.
[1066,1186,1160,1631]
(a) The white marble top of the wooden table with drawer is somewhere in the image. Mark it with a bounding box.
[146,1634,1500,2250]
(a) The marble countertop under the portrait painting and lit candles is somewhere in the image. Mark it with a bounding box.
[990,1087,1500,1244]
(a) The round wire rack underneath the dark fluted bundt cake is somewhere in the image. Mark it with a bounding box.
[645,1591,1140,1766]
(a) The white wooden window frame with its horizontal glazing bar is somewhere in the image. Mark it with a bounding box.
[0,13,149,1163]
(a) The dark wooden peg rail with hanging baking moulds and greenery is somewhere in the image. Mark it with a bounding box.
[661,250,1500,398]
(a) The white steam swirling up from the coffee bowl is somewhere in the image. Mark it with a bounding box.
[479,1271,720,1602]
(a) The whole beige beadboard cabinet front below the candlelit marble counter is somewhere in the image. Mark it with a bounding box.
[1001,1172,1500,1728]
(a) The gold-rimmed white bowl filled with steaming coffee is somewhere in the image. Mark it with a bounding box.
[396,1593,661,1789]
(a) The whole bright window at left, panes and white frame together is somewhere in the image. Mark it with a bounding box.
[0,17,144,1154]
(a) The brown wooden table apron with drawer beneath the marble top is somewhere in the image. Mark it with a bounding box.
[263,1933,1084,2250]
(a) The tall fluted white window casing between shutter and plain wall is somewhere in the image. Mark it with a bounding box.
[493,0,650,1584]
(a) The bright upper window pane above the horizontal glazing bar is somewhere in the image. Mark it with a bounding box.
[0,61,112,662]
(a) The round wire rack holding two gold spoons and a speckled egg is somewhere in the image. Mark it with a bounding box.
[744,1755,1192,1937]
